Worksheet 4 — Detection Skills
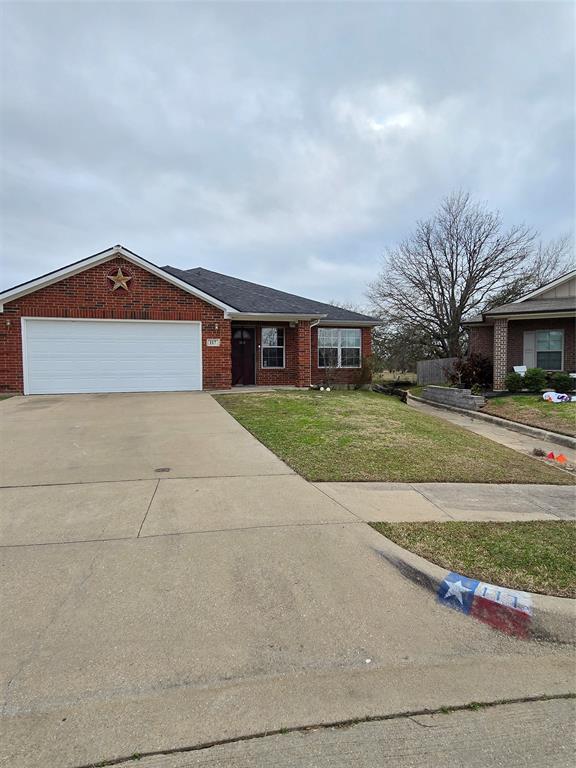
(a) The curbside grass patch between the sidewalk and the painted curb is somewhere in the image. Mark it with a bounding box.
[370,520,576,597]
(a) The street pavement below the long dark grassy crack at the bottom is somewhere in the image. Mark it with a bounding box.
[110,699,576,768]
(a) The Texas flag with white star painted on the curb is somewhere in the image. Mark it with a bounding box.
[438,573,532,637]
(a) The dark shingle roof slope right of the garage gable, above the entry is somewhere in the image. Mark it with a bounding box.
[162,266,377,322]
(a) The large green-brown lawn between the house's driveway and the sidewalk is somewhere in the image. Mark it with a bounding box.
[216,390,574,485]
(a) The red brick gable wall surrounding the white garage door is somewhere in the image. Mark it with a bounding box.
[0,258,232,392]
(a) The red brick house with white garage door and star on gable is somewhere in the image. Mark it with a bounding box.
[0,245,377,394]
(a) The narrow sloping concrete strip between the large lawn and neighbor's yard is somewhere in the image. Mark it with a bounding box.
[408,397,576,464]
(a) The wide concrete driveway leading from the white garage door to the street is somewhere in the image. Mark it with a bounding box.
[0,393,573,768]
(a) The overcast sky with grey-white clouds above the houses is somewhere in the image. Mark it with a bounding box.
[0,1,575,303]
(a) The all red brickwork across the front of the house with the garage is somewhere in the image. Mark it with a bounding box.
[0,258,372,393]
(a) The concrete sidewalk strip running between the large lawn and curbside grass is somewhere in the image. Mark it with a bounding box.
[314,483,576,522]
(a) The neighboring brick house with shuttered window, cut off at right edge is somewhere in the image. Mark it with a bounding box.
[464,270,576,390]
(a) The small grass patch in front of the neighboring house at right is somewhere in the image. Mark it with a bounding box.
[482,395,576,437]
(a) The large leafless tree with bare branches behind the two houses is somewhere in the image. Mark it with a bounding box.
[368,192,569,357]
